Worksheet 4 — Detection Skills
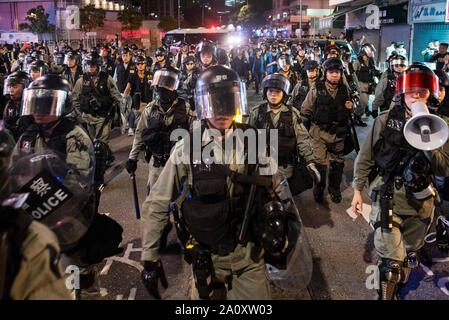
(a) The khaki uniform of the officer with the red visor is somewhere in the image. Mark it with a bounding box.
[353,104,449,270]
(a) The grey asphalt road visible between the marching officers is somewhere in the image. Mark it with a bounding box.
[90,89,449,300]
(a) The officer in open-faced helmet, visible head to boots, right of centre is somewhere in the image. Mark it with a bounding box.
[301,58,353,203]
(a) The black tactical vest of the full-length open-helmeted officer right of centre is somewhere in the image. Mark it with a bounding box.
[312,81,349,136]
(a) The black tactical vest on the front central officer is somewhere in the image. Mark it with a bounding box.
[182,120,255,256]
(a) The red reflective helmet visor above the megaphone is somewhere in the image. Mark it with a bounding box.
[395,72,439,98]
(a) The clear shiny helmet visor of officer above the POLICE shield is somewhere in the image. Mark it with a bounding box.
[20,88,67,117]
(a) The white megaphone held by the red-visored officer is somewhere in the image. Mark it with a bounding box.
[404,102,449,150]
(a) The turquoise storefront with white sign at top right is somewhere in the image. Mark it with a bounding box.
[408,0,449,62]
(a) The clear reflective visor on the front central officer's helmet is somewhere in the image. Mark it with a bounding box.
[195,81,248,120]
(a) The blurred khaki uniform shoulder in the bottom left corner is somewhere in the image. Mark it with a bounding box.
[0,206,73,300]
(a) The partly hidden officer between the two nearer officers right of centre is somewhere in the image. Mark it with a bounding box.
[287,60,319,111]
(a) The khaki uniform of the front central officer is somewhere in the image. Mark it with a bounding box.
[142,120,294,300]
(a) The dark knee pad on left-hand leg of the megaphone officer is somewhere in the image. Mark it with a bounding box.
[379,258,403,300]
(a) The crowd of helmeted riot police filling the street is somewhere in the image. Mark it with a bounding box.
[0,36,449,299]
